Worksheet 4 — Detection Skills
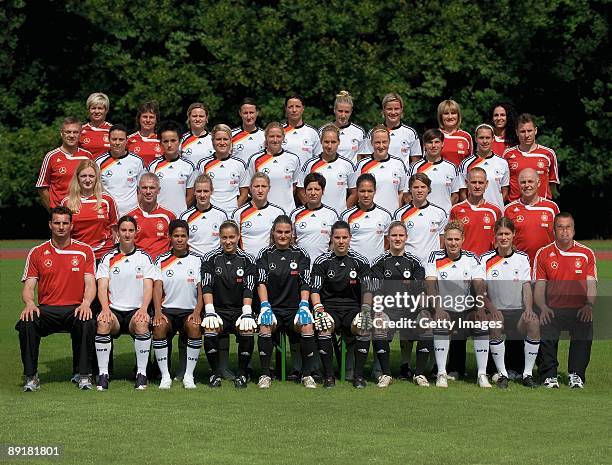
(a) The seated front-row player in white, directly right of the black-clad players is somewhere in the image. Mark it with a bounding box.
[425,221,491,388]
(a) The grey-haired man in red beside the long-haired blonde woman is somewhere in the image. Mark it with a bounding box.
[128,173,176,261]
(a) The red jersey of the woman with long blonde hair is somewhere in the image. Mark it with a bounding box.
[62,193,119,259]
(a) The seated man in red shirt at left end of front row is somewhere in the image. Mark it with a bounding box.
[15,207,96,392]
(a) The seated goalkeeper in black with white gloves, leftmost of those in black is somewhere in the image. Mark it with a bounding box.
[202,220,257,388]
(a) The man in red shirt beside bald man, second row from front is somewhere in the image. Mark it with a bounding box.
[448,166,502,255]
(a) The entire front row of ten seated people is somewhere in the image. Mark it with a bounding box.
[16,207,596,391]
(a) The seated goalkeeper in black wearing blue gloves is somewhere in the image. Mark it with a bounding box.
[257,215,317,389]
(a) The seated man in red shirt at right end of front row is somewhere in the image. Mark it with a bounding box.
[533,212,597,389]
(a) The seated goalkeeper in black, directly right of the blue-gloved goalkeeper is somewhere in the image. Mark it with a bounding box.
[310,221,372,388]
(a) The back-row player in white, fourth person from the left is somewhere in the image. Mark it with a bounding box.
[232,97,265,165]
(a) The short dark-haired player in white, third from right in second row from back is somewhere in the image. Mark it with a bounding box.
[409,129,460,215]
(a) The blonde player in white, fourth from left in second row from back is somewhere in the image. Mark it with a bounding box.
[197,124,249,214]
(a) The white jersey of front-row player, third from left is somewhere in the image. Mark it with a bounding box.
[155,251,202,310]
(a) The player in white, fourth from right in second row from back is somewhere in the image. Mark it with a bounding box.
[348,124,408,211]
